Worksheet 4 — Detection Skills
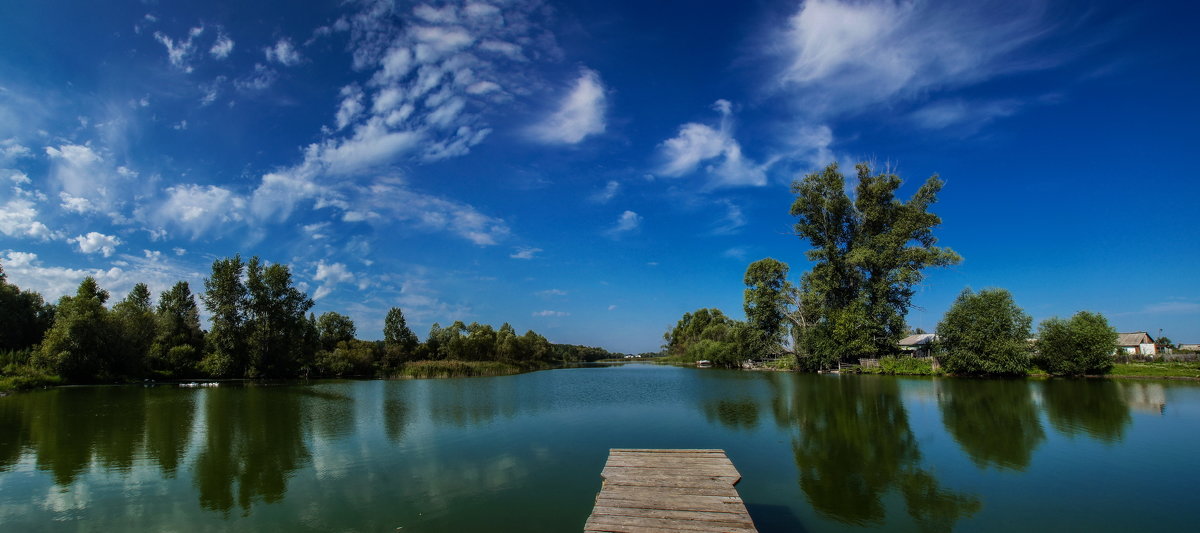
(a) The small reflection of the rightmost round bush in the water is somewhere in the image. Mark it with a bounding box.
[1042,379,1129,443]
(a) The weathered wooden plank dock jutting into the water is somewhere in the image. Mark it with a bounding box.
[583,449,757,533]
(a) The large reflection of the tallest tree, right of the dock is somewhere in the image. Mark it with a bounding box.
[768,376,980,531]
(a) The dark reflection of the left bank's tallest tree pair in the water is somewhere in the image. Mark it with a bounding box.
[194,387,308,513]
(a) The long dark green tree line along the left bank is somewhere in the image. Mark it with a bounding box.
[0,256,612,383]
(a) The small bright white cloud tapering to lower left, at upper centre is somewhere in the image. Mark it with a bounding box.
[529,68,606,144]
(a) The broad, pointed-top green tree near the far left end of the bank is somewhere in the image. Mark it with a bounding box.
[34,276,114,382]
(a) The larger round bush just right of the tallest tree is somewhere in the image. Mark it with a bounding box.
[936,288,1032,376]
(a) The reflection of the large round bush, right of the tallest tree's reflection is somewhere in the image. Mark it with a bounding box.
[937,378,1045,471]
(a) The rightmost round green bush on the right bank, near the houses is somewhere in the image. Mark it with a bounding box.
[1038,311,1117,376]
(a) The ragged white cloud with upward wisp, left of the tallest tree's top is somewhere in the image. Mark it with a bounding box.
[658,100,772,187]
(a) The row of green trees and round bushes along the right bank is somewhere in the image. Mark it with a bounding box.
[664,163,1116,375]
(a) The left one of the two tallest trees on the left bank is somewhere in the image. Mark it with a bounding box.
[200,254,247,377]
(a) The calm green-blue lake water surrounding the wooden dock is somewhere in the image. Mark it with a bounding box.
[0,365,1200,532]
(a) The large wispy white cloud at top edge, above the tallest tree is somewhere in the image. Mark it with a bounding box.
[774,0,1056,114]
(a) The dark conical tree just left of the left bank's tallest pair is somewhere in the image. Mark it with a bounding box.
[149,281,204,377]
